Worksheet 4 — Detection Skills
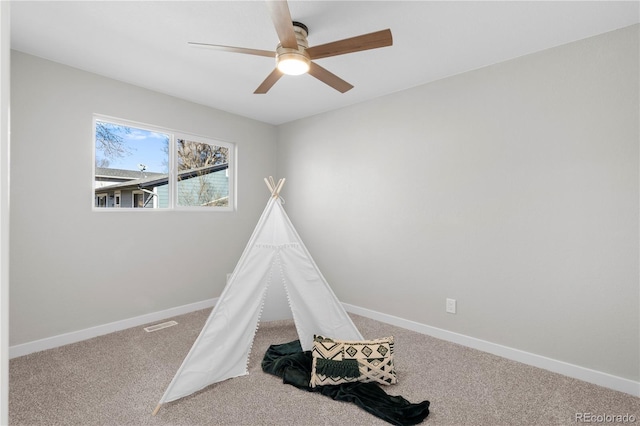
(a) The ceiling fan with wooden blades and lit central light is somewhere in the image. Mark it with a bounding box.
[188,0,393,94]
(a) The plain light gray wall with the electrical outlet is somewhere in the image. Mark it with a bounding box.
[277,25,640,381]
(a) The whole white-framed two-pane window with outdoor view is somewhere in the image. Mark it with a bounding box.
[93,116,234,211]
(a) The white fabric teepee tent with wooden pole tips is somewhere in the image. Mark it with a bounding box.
[154,178,362,414]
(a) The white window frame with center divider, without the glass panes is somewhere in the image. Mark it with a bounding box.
[91,114,237,213]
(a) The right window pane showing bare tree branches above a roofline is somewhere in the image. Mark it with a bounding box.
[176,139,229,207]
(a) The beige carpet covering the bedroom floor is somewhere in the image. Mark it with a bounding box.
[9,310,640,426]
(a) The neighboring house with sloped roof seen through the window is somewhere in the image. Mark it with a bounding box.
[94,163,229,208]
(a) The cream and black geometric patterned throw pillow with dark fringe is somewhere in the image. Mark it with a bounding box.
[309,336,398,388]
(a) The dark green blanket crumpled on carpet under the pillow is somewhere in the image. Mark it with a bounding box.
[262,340,429,425]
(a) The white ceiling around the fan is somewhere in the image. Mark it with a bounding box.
[11,0,640,124]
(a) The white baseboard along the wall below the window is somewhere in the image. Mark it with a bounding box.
[9,297,218,358]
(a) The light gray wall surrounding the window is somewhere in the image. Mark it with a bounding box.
[10,52,276,345]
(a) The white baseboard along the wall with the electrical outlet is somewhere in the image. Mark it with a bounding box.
[343,303,640,397]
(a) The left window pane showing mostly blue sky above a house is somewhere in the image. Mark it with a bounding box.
[94,120,169,208]
